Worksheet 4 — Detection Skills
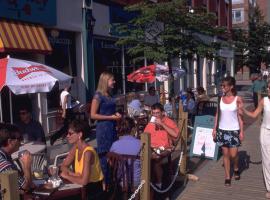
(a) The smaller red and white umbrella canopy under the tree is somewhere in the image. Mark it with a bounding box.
[127,64,186,83]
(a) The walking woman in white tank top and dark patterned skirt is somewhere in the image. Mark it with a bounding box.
[213,76,244,186]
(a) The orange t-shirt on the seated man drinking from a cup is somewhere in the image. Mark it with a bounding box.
[144,117,179,148]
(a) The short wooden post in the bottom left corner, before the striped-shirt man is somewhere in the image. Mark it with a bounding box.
[0,170,20,200]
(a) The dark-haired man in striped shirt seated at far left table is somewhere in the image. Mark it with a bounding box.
[0,123,32,191]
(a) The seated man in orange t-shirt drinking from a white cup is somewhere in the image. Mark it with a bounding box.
[144,103,179,188]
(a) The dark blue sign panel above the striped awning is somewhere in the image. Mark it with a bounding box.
[0,0,56,26]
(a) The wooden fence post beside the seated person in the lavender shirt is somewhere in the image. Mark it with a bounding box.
[140,133,151,200]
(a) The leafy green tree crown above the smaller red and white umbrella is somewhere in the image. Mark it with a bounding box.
[117,0,225,62]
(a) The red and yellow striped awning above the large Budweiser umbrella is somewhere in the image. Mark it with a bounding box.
[0,21,52,54]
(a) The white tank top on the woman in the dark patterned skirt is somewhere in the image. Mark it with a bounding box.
[219,96,240,131]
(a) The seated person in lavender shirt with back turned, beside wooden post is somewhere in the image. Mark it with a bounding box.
[110,117,141,186]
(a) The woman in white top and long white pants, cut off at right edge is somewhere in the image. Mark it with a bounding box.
[243,82,270,199]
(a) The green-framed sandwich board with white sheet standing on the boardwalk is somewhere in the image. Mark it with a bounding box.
[190,115,218,160]
